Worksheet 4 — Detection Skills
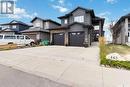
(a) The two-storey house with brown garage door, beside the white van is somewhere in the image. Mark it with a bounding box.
[22,17,60,41]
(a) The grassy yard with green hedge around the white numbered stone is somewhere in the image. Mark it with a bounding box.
[100,38,130,70]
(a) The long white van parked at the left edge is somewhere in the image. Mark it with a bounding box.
[0,34,34,45]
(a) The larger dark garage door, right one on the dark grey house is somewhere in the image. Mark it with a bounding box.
[69,32,85,46]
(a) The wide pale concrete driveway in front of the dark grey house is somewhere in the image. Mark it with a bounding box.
[0,45,130,87]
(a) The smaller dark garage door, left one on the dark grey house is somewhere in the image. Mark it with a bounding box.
[53,33,65,45]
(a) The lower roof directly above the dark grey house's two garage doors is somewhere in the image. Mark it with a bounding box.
[49,22,93,30]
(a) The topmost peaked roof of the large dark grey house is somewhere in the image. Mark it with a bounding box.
[58,6,95,19]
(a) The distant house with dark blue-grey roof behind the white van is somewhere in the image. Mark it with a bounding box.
[0,20,30,34]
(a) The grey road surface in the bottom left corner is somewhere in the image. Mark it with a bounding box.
[0,65,69,87]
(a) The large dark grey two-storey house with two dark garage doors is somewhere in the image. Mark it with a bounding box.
[49,7,105,46]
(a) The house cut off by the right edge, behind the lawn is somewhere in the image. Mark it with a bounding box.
[111,14,130,44]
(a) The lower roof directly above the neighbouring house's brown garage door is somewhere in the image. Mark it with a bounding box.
[21,27,49,33]
